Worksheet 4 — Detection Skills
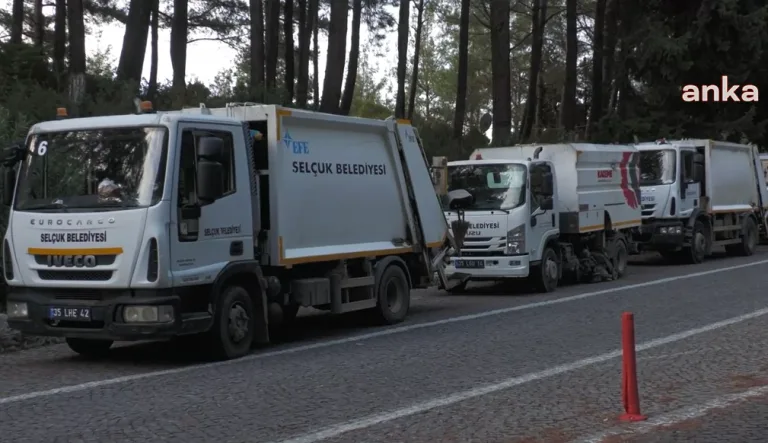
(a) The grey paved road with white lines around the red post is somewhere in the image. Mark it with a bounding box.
[0,247,768,443]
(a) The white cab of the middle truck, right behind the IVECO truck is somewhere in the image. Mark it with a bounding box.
[446,160,559,292]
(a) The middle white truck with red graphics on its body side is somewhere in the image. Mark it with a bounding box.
[444,143,641,292]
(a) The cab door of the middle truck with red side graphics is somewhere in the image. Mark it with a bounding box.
[526,162,557,260]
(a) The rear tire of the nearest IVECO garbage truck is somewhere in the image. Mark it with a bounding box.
[374,264,411,325]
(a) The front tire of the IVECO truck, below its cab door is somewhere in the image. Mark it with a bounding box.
[208,285,256,360]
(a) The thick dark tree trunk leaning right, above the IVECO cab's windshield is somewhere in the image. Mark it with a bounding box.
[117,0,153,83]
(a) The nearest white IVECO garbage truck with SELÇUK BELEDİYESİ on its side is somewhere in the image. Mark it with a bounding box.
[3,103,462,358]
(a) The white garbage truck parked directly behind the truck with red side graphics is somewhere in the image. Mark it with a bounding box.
[635,139,768,263]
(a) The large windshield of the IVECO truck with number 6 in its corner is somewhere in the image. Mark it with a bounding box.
[14,127,168,212]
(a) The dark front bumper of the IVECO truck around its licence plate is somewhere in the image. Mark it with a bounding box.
[7,287,212,341]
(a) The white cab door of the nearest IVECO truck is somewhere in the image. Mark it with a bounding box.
[170,123,253,286]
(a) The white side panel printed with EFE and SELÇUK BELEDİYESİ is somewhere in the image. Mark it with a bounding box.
[270,111,424,265]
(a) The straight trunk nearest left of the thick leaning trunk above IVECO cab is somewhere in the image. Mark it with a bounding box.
[67,0,85,117]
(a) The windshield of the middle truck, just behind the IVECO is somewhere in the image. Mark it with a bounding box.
[448,163,527,211]
